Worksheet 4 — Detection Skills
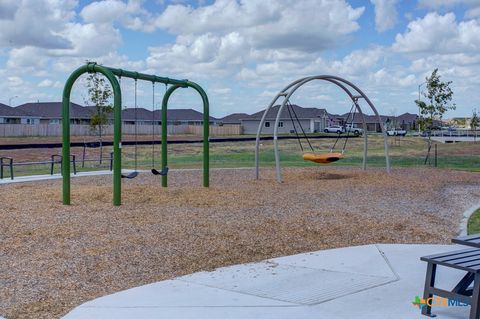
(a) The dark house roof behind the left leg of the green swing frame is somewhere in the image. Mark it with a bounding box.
[15,102,92,119]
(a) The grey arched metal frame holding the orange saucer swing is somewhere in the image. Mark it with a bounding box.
[255,75,390,183]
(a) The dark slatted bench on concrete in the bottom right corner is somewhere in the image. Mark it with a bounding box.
[420,248,480,319]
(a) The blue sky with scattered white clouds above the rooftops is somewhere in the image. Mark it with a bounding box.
[0,0,480,117]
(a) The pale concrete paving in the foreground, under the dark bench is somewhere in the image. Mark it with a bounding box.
[64,244,470,319]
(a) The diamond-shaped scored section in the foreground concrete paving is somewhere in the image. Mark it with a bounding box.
[178,260,396,305]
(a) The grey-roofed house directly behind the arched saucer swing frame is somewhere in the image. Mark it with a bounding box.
[240,105,329,134]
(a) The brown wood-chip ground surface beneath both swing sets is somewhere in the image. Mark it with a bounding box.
[0,167,480,319]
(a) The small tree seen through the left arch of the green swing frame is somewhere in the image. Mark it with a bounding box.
[85,73,113,163]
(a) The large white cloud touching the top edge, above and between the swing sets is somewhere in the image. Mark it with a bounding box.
[156,0,364,51]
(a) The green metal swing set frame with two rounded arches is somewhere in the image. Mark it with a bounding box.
[62,62,210,206]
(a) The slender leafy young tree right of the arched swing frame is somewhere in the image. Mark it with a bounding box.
[415,69,456,164]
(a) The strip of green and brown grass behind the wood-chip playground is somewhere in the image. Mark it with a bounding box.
[0,135,480,176]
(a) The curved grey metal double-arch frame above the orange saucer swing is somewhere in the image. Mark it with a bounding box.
[255,75,390,182]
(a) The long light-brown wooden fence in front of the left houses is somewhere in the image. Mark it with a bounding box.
[0,124,242,137]
